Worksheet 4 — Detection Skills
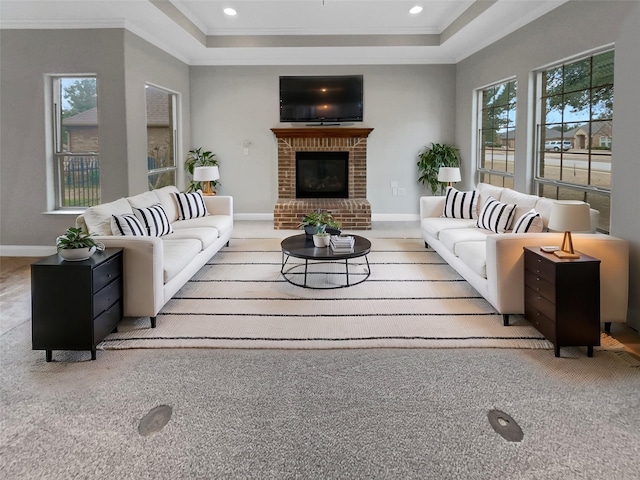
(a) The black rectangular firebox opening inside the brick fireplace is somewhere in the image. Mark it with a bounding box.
[296,151,349,198]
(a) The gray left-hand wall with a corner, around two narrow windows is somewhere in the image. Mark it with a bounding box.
[0,29,190,254]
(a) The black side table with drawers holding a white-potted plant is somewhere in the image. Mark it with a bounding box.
[31,248,122,362]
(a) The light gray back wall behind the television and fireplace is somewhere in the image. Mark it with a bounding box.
[190,65,455,219]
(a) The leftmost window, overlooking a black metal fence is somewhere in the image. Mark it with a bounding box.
[50,76,100,210]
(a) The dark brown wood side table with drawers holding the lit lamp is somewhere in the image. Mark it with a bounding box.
[524,247,600,357]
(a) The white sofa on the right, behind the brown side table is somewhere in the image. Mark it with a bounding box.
[420,183,629,331]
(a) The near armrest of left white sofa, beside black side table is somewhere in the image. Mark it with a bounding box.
[93,235,165,317]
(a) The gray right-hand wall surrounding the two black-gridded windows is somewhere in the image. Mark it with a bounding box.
[455,1,640,329]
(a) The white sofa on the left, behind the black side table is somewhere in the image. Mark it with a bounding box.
[76,186,233,328]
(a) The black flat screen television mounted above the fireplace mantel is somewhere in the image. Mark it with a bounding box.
[280,75,363,124]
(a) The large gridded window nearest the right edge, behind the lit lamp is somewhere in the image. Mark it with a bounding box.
[535,50,614,231]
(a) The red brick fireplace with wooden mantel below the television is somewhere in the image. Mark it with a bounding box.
[271,127,373,230]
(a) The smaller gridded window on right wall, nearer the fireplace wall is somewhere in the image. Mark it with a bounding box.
[477,80,517,188]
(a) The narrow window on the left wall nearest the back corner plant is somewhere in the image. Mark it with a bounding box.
[145,85,178,190]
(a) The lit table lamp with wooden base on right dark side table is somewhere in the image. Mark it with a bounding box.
[549,200,591,258]
